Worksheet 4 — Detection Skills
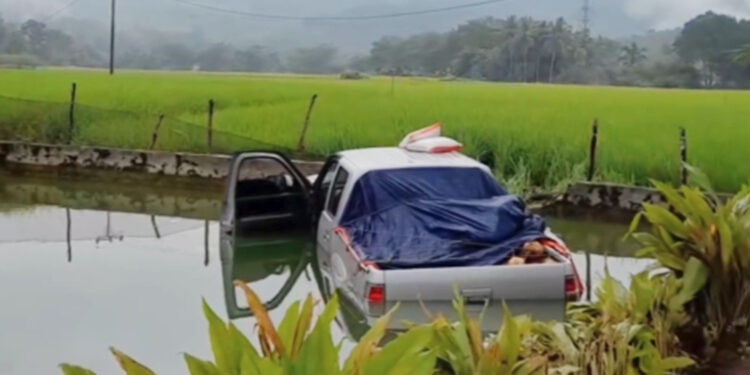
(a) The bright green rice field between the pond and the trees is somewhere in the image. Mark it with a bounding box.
[0,70,750,191]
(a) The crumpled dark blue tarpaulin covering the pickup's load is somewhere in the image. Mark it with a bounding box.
[341,167,545,269]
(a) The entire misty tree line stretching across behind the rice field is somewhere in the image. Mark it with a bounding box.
[0,12,750,88]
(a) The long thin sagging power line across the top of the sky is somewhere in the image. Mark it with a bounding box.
[168,0,508,21]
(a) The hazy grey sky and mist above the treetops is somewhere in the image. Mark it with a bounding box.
[0,0,750,44]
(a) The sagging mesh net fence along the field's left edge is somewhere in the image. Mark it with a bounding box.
[0,96,319,157]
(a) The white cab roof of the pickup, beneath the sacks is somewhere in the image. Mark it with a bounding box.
[338,147,490,175]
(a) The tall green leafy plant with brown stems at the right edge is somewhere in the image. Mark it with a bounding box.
[631,169,750,357]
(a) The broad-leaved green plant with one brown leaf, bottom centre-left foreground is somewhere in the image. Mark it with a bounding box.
[61,282,437,375]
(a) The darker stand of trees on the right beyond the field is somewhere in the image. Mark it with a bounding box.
[354,12,750,87]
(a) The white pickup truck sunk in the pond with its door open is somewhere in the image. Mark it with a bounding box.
[222,142,583,324]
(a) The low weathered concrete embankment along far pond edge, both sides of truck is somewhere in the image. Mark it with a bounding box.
[0,141,692,216]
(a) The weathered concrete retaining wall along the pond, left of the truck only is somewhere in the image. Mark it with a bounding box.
[0,141,322,180]
